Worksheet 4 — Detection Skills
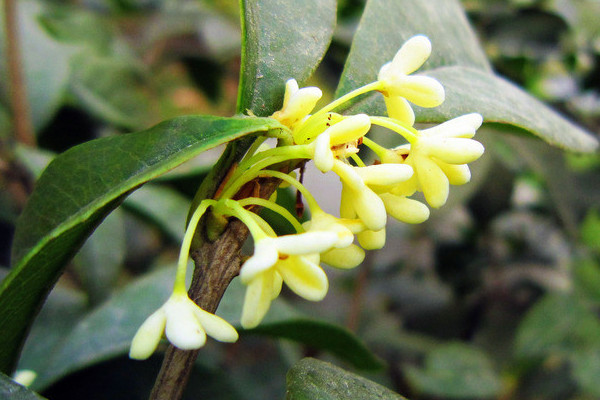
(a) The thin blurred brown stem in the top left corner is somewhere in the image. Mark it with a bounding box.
[4,0,36,146]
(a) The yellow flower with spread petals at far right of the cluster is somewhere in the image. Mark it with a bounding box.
[386,113,484,208]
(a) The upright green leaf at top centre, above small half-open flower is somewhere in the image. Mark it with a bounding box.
[238,0,336,116]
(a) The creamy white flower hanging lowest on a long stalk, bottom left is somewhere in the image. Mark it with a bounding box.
[129,293,238,360]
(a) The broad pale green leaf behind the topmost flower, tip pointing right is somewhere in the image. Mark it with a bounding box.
[337,0,598,152]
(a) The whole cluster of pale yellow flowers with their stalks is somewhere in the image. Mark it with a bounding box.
[130,35,484,359]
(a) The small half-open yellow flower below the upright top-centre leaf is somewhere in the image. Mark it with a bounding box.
[271,79,323,129]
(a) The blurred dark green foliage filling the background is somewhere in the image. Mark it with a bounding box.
[0,0,600,400]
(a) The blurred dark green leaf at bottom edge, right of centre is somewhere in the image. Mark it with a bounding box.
[406,343,501,399]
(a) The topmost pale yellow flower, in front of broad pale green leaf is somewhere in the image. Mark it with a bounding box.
[378,35,445,126]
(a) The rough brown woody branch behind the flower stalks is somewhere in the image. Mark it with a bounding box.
[150,178,280,400]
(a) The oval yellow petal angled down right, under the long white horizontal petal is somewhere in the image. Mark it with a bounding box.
[277,256,329,301]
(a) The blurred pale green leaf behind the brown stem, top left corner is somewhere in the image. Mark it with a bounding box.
[0,1,76,131]
